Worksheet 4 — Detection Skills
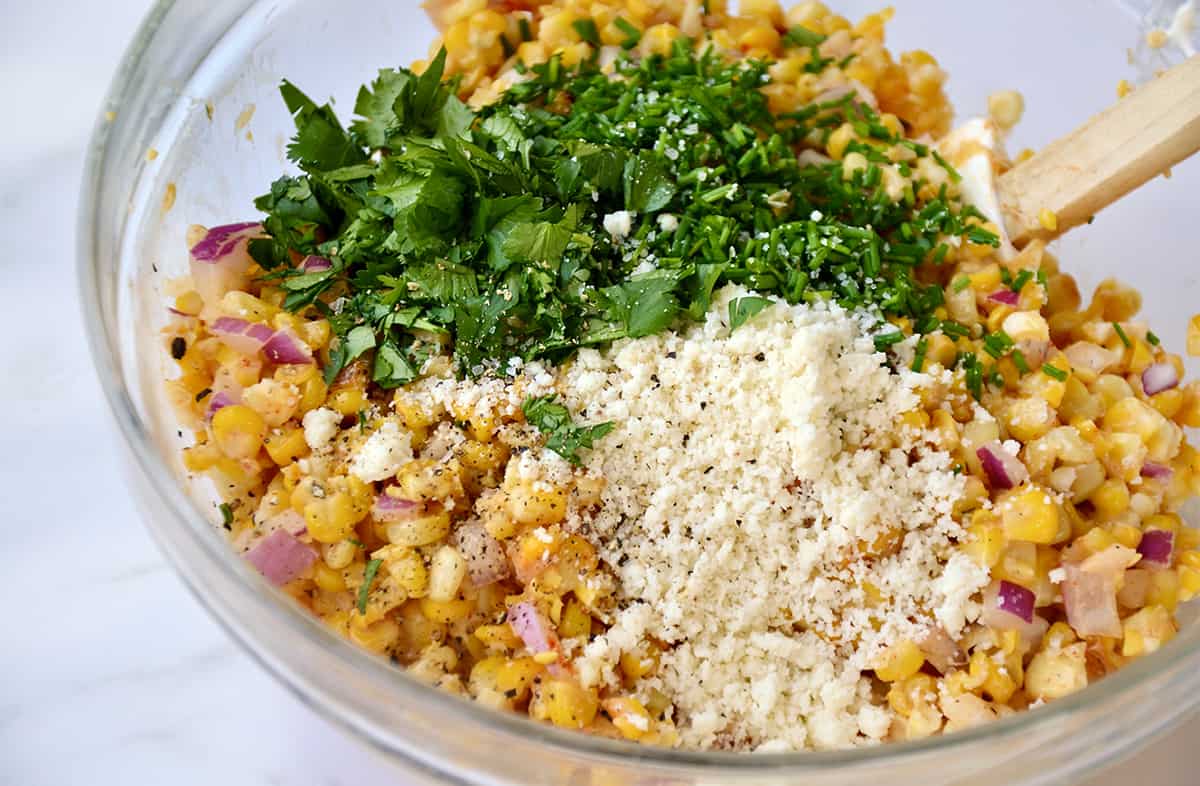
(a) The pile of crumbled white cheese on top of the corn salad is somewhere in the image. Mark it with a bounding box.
[559,288,986,750]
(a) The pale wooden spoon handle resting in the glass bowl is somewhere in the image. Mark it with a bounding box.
[996,55,1200,246]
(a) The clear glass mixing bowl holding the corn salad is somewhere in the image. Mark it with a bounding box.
[79,0,1200,786]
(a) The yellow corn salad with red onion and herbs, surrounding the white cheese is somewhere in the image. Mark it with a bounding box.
[166,0,1200,749]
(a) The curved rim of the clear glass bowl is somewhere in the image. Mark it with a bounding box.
[77,0,1200,778]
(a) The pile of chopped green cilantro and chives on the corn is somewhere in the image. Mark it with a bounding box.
[251,36,996,391]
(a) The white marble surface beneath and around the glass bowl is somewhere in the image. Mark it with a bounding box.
[0,0,1200,786]
